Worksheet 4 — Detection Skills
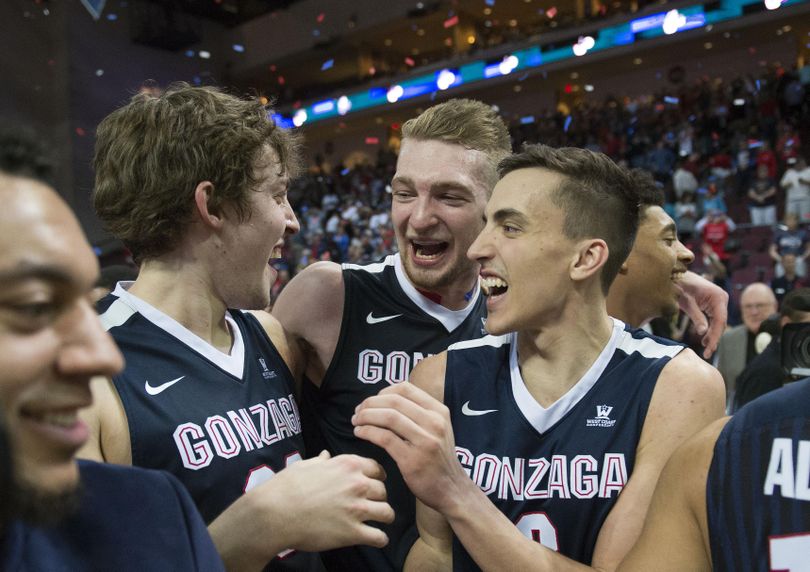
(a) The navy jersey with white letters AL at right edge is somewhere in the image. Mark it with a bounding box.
[706,380,810,571]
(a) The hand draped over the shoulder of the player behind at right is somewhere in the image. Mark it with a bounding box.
[679,271,728,359]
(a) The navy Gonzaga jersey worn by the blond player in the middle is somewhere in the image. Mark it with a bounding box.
[302,255,486,572]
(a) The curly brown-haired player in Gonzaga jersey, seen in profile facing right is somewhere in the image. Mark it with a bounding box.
[79,84,393,570]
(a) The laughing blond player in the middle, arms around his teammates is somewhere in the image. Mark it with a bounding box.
[273,99,728,571]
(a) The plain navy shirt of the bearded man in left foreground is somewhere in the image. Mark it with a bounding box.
[0,461,224,572]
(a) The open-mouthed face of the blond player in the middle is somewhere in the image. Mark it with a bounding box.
[391,139,491,294]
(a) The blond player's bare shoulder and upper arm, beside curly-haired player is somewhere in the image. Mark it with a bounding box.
[273,262,345,386]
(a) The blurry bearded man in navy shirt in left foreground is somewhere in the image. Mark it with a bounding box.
[0,130,223,572]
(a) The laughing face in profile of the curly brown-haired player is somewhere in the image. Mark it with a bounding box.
[216,147,300,310]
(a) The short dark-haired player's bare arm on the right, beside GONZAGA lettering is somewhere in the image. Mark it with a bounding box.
[592,349,725,570]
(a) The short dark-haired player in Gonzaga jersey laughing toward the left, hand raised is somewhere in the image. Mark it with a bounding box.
[354,145,724,570]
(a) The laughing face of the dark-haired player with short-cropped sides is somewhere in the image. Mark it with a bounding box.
[468,168,576,335]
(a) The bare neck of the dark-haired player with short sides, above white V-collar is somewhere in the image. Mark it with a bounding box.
[517,306,613,408]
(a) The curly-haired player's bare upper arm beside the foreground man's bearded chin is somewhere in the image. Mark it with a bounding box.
[76,377,132,465]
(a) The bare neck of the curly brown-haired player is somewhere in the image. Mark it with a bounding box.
[129,256,233,353]
